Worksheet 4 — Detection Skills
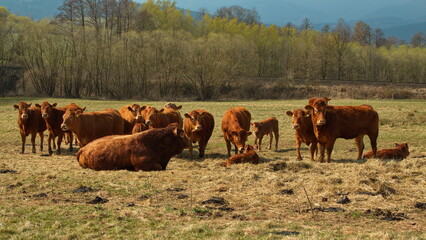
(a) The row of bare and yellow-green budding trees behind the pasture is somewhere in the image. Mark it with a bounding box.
[0,0,426,100]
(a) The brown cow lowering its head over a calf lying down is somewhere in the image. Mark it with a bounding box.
[222,107,251,156]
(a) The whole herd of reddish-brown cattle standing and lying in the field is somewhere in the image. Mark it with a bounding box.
[13,97,409,171]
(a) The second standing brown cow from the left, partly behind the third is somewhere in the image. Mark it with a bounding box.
[36,102,86,155]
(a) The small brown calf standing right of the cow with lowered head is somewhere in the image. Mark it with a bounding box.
[251,117,279,152]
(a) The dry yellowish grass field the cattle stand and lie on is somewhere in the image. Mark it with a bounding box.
[0,98,426,239]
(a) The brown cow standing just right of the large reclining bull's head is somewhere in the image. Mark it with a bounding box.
[184,109,214,158]
